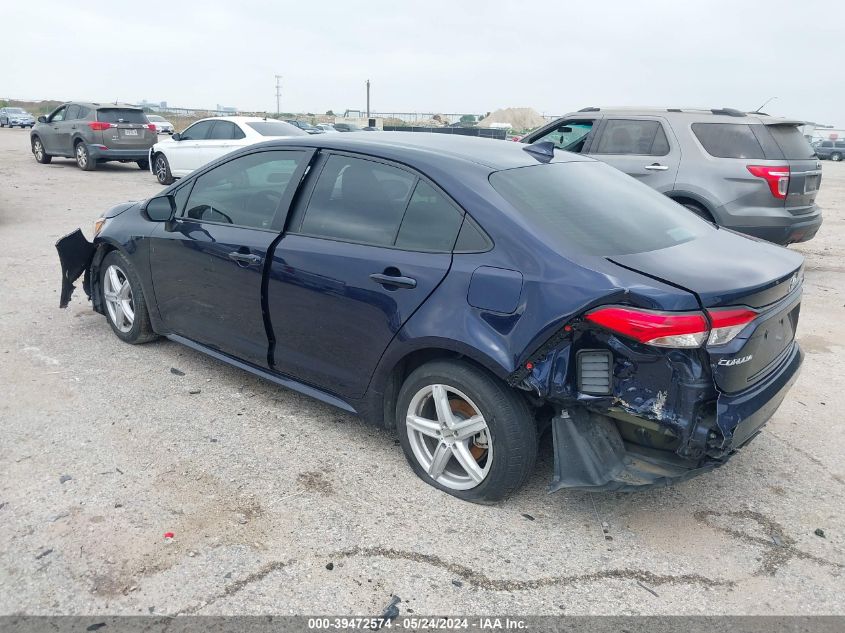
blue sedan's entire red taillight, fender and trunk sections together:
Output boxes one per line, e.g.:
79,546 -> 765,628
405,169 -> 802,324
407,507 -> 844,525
585,306 -> 757,348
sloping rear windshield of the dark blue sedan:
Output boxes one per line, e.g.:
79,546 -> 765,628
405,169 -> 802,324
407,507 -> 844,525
490,161 -> 713,256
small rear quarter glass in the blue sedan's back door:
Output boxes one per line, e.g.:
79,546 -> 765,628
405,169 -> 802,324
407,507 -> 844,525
395,180 -> 462,253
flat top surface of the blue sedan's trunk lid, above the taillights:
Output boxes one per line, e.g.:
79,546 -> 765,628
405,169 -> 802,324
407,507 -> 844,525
607,229 -> 804,307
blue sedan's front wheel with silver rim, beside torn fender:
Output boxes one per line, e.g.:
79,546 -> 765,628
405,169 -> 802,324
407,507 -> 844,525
100,251 -> 157,345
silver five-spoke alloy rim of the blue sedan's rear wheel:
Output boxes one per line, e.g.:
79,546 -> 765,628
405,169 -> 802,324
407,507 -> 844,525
405,384 -> 493,490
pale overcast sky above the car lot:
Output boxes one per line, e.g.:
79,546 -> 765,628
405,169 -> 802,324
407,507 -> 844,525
0,0 -> 845,126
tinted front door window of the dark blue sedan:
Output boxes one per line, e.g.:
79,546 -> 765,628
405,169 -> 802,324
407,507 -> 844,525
184,151 -> 305,229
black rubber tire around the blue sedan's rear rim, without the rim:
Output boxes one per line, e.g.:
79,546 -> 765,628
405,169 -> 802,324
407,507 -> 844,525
396,361 -> 537,503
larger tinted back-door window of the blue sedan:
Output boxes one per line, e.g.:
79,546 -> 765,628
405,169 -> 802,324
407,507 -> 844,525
301,155 -> 416,246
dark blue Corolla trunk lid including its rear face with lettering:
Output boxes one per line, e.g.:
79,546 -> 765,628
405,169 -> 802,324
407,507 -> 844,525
608,229 -> 803,393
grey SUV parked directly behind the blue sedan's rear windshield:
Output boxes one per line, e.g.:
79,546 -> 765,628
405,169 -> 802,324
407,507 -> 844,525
522,108 -> 822,244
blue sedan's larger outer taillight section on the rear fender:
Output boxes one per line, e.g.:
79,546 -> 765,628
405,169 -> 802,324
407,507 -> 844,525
585,307 -> 710,347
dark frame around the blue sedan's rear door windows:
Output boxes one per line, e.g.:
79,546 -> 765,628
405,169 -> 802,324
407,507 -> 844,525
284,149 -> 474,254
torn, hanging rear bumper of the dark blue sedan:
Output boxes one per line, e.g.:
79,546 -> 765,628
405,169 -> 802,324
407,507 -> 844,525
550,343 -> 804,492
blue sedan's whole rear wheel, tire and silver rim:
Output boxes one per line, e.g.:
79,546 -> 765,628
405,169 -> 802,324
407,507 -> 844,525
396,361 -> 537,503
